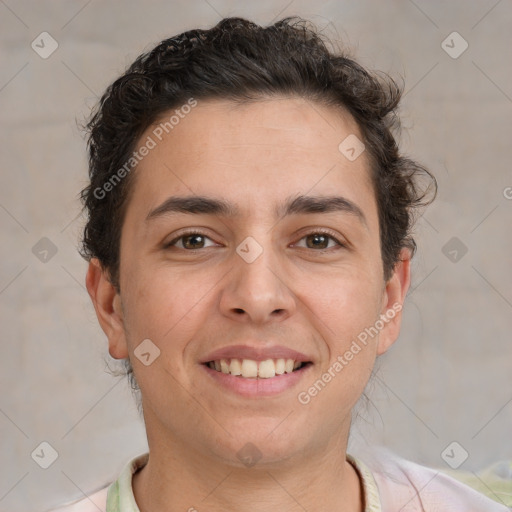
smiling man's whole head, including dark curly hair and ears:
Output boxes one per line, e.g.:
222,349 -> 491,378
82,18 -> 435,463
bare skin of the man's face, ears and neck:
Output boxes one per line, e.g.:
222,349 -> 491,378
86,97 -> 410,512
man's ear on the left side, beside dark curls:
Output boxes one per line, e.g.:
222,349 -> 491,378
85,258 -> 128,359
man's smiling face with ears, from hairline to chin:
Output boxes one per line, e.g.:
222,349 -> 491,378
87,98 -> 409,465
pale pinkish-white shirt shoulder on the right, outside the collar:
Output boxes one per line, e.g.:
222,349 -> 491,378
359,451 -> 509,512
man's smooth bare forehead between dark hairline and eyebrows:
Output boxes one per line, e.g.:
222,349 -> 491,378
124,98 -> 374,224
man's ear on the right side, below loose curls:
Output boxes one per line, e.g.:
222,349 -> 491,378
377,248 -> 411,356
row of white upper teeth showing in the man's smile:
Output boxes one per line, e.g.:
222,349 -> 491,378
208,359 -> 302,379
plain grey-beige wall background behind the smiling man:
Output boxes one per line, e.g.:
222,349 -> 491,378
0,0 -> 512,512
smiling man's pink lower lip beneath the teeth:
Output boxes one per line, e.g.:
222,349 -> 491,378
201,364 -> 312,398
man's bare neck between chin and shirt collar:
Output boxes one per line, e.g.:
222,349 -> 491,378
133,420 -> 363,512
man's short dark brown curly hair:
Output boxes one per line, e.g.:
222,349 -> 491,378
81,17 -> 437,291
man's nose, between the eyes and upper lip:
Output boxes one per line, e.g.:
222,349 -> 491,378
220,241 -> 296,324
